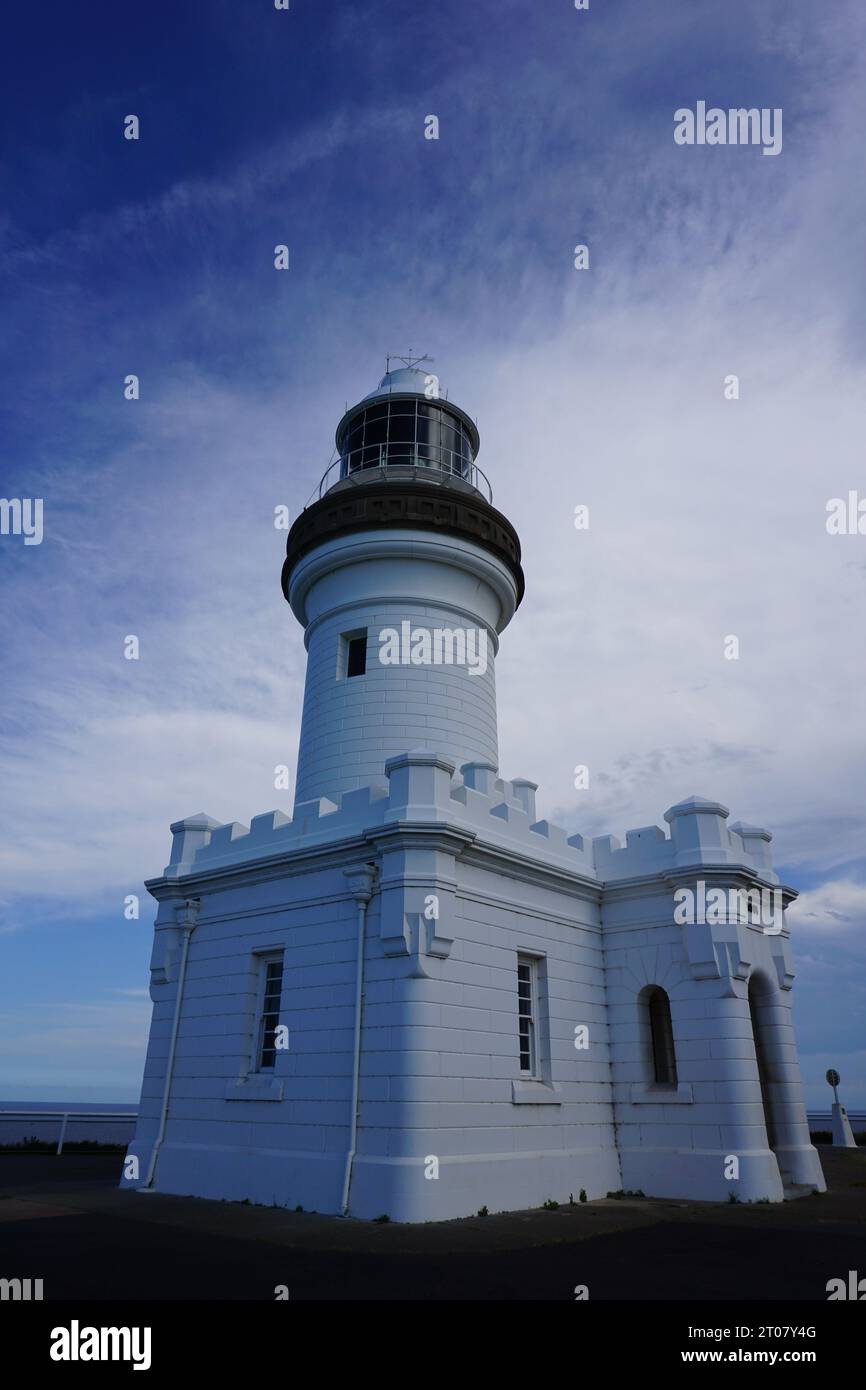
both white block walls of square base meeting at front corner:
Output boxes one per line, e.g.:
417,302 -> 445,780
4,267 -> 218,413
131,834 -> 620,1220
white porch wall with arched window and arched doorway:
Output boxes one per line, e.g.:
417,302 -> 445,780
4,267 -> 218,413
603,890 -> 824,1202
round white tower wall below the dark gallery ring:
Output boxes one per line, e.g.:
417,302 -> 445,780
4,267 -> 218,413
288,528 -> 517,805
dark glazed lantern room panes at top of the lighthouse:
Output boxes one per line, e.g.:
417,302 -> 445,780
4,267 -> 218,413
339,398 -> 473,478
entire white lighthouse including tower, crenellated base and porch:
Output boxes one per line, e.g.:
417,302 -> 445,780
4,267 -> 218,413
124,359 -> 824,1222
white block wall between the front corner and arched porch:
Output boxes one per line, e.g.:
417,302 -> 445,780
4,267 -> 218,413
352,870 -> 621,1220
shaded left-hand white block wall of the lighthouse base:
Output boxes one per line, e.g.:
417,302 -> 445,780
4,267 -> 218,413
131,867 -> 377,1211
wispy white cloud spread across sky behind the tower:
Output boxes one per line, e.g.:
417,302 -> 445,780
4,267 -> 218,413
0,0 -> 866,930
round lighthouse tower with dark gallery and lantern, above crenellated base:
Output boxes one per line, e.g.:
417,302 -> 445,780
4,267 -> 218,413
282,367 -> 524,803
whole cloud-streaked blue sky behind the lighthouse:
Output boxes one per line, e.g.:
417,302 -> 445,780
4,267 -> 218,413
0,0 -> 866,1106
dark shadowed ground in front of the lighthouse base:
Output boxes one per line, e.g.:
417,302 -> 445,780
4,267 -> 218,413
0,1148 -> 866,1302
